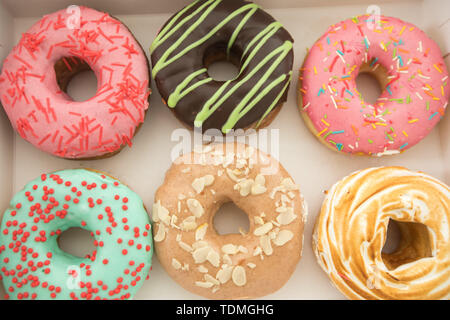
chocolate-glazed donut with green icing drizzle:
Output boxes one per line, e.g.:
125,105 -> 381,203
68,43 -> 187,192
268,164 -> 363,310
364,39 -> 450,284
150,0 -> 293,134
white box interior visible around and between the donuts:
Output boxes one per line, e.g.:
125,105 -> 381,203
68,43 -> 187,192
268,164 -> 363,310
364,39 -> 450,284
0,0 -> 450,299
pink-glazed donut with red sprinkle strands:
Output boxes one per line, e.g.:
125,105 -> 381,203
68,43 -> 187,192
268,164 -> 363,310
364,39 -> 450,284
0,6 -> 150,159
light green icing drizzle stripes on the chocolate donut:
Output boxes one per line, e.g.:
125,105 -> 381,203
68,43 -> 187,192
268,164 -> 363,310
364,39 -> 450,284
150,0 -> 293,133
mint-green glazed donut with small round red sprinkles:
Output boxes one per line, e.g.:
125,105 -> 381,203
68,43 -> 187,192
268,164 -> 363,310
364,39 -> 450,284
0,169 -> 153,300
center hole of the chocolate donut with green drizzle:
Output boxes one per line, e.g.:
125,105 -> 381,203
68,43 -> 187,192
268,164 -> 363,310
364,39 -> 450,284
203,43 -> 240,82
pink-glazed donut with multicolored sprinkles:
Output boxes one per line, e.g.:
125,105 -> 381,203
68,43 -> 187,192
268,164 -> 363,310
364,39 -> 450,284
298,15 -> 450,156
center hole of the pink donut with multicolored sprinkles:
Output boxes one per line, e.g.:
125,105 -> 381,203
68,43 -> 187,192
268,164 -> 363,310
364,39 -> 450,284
355,63 -> 388,105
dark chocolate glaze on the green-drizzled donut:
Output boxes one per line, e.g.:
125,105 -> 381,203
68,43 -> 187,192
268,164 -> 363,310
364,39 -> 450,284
151,0 -> 293,132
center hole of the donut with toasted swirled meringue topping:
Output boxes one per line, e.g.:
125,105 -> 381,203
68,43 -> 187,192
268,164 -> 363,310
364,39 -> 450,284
381,219 -> 433,270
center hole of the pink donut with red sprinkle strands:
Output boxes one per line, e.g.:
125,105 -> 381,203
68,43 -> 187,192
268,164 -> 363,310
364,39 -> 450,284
54,57 -> 97,102
